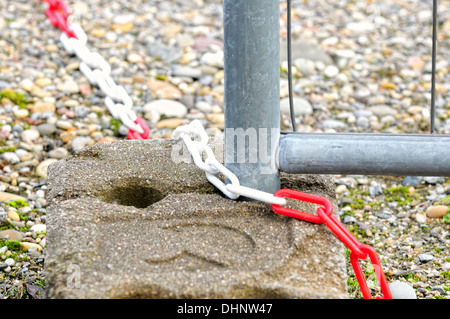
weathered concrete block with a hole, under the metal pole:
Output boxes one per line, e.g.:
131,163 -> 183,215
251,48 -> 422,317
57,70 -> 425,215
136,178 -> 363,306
45,139 -> 349,299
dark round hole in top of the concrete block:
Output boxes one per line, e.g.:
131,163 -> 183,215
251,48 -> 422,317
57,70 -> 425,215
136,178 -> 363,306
102,185 -> 165,208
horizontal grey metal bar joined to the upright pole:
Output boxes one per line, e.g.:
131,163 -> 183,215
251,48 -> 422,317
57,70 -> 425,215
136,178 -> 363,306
277,133 -> 450,176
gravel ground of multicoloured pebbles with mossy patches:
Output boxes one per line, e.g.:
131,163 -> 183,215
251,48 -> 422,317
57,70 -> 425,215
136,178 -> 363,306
0,0 -> 450,299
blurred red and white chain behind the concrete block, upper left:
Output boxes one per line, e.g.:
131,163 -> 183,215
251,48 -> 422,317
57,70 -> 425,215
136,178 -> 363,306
41,0 -> 150,139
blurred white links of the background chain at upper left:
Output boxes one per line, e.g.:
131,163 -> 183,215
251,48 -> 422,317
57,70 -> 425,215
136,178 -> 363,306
60,23 -> 144,134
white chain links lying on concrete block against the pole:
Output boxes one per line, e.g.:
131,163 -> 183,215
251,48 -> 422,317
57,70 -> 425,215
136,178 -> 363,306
172,120 -> 286,205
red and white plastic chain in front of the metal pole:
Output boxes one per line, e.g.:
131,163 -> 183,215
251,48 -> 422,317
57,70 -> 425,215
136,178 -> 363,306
172,120 -> 392,299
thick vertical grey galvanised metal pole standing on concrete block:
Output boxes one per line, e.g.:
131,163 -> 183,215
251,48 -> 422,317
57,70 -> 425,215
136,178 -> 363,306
223,0 -> 280,193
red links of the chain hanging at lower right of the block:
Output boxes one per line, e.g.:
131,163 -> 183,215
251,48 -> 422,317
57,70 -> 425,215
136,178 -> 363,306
271,188 -> 392,299
